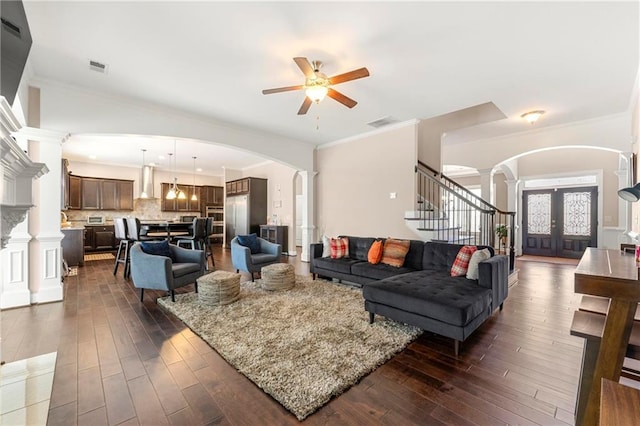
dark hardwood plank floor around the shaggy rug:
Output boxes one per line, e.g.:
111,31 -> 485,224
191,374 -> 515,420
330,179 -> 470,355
2,249 -> 582,426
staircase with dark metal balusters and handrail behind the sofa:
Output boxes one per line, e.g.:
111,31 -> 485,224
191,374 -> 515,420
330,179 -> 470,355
405,162 -> 515,270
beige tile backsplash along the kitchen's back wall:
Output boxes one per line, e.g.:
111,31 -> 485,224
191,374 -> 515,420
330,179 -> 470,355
65,198 -> 200,223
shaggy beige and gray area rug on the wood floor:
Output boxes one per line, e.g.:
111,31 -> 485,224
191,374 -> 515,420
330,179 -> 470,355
158,276 -> 421,420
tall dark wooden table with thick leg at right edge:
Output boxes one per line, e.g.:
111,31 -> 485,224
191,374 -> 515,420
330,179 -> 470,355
572,247 -> 640,426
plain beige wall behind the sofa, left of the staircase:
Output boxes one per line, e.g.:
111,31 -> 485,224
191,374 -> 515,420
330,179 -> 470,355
316,124 -> 418,238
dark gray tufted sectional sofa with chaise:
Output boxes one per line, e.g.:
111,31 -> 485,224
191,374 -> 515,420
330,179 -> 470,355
310,237 -> 509,356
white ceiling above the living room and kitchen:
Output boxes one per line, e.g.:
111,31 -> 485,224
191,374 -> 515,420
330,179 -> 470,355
20,0 -> 639,170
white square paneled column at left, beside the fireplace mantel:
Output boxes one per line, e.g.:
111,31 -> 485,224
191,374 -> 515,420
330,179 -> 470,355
14,127 -> 69,303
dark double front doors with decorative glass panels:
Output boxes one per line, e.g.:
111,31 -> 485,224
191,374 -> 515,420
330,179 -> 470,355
522,186 -> 598,259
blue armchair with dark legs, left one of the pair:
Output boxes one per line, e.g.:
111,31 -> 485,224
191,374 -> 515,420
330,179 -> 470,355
130,243 -> 205,302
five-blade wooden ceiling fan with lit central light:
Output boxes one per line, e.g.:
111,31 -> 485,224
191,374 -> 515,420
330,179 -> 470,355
262,57 -> 369,115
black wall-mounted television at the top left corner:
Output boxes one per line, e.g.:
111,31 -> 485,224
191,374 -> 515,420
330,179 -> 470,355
0,0 -> 31,105
